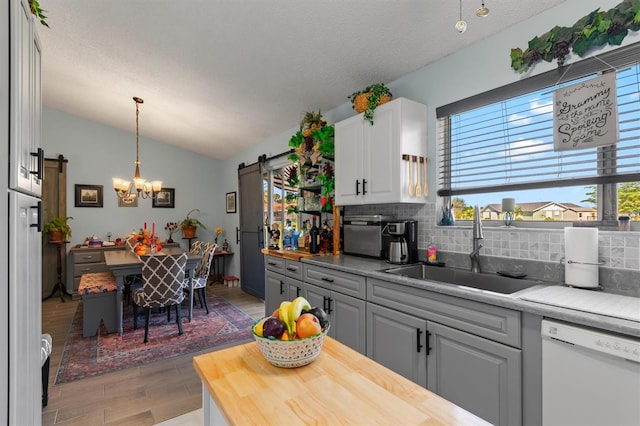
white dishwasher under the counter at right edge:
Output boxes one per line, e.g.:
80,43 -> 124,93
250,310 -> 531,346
542,319 -> 640,426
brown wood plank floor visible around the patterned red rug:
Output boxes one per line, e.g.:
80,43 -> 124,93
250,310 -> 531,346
42,284 -> 264,425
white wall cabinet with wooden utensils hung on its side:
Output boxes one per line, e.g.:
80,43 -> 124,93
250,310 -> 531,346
335,98 -> 427,206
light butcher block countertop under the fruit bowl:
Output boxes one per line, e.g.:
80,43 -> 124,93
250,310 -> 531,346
193,337 -> 488,425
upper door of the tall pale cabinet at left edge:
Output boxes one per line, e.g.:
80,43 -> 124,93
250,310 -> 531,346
9,0 -> 44,196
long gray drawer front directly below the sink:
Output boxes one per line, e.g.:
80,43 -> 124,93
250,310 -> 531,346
367,278 -> 522,348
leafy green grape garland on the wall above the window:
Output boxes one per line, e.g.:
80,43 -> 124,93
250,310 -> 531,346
511,0 -> 640,74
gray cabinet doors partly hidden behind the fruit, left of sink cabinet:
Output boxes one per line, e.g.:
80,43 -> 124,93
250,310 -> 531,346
302,283 -> 367,355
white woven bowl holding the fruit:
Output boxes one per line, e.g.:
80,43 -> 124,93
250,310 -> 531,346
251,318 -> 331,368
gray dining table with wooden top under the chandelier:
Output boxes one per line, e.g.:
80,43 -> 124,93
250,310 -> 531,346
104,247 -> 202,335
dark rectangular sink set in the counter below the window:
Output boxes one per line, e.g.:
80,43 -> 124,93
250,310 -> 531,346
384,264 -> 541,294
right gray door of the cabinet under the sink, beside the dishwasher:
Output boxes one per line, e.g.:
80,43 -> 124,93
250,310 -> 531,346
427,321 -> 522,425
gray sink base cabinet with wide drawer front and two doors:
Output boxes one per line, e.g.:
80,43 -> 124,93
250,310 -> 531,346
367,279 -> 523,425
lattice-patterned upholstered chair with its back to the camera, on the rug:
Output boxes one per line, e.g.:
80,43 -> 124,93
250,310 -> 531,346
131,253 -> 187,343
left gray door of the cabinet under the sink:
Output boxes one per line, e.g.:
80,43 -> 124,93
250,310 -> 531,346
367,303 -> 428,387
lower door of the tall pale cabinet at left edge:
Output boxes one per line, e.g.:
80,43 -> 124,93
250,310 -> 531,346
5,191 -> 42,425
